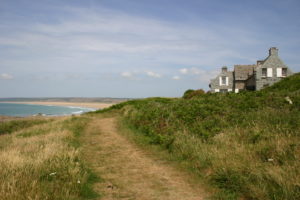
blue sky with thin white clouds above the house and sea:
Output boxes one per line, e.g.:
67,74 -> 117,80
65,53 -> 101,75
0,0 -> 300,98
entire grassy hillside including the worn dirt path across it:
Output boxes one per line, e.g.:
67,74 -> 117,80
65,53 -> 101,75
0,74 -> 300,200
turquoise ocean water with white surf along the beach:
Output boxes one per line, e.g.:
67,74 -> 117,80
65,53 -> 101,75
0,103 -> 94,117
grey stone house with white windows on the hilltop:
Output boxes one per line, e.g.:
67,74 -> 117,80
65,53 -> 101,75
209,47 -> 292,93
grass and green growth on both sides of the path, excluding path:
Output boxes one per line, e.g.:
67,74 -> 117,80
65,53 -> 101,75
0,74 -> 300,200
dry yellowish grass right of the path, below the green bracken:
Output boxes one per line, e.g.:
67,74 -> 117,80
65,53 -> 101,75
172,129 -> 300,200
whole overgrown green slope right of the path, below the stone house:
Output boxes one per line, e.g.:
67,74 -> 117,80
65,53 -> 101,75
100,73 -> 300,200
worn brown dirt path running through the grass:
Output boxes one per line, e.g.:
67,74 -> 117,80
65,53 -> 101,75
84,118 -> 204,200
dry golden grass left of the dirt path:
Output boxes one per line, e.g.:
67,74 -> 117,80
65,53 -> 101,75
0,117 -> 98,200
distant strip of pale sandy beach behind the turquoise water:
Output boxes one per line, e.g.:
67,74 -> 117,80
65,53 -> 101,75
3,101 -> 113,109
